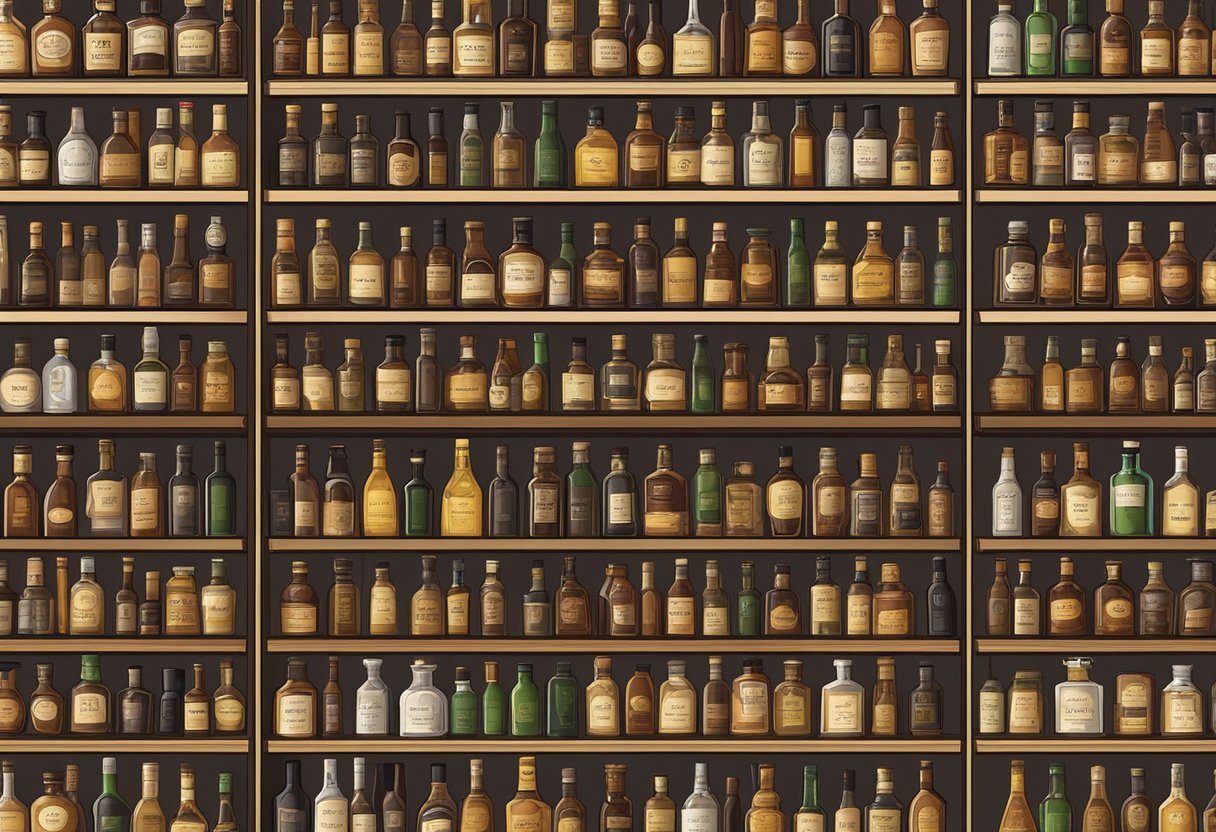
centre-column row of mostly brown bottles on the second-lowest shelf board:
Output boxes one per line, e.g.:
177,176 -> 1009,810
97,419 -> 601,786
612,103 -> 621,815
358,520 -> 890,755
278,555 -> 958,639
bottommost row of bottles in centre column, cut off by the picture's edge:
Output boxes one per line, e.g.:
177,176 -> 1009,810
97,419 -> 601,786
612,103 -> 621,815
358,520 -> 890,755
272,757 -> 946,832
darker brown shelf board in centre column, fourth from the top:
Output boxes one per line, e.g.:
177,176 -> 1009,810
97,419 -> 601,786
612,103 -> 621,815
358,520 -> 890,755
266,414 -> 958,434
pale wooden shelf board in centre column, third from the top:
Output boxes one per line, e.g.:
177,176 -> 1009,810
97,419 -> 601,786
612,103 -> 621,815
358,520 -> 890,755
266,307 -> 958,326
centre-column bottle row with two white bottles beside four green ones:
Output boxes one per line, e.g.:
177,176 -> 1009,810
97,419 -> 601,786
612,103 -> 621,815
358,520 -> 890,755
274,656 -> 942,738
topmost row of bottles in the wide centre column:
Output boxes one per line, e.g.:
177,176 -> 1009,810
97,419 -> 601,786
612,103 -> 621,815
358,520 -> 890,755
271,0 -> 950,78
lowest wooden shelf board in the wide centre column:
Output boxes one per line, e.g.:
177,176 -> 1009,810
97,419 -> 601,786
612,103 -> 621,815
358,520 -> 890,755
266,737 -> 958,754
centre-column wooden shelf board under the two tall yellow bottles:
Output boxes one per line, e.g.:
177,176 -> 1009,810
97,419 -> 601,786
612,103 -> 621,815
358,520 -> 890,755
266,538 -> 958,555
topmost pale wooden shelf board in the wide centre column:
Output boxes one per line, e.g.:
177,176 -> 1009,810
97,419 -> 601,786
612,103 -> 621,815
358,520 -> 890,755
265,78 -> 962,97
